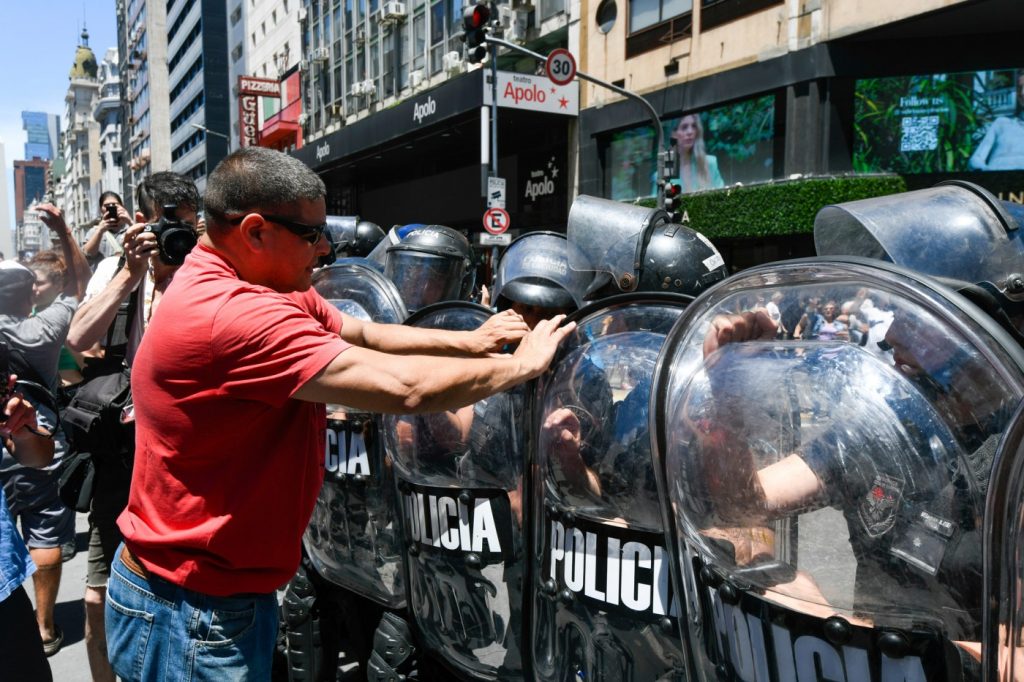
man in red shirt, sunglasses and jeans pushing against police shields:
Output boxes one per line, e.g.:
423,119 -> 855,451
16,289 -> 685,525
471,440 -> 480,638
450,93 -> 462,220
106,147 -> 572,680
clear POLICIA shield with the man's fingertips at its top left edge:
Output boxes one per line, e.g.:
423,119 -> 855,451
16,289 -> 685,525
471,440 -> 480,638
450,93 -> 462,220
529,294 -> 690,682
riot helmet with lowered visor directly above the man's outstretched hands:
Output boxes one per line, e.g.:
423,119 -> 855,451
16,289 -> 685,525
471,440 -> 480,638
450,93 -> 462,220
493,231 -> 592,311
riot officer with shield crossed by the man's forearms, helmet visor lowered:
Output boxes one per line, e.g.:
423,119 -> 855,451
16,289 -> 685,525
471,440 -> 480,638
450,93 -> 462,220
370,232 -> 590,680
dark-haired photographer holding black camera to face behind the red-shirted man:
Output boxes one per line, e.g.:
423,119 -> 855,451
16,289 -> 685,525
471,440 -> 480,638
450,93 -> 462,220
68,172 -> 200,682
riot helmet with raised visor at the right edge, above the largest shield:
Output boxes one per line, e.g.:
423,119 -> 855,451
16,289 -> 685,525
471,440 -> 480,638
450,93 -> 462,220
814,180 -> 1024,332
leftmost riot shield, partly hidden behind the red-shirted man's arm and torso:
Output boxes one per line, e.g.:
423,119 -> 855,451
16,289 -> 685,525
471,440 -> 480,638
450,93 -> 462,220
303,258 -> 407,608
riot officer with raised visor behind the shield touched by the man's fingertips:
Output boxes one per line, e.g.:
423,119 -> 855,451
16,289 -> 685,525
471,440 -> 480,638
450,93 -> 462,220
529,197 -> 727,680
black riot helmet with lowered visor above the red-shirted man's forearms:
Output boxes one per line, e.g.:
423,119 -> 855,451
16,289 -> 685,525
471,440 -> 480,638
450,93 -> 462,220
384,225 -> 474,312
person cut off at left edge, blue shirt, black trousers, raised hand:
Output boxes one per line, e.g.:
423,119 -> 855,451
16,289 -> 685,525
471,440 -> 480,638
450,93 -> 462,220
0,385 -> 53,682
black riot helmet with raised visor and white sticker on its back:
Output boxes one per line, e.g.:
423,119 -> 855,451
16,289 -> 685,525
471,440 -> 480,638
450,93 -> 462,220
567,191 -> 729,300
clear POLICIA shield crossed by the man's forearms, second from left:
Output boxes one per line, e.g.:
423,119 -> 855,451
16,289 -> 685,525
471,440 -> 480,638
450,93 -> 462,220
386,301 -> 525,680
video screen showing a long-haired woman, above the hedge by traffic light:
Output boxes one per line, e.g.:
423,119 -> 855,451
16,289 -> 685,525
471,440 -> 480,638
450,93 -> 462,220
605,95 -> 775,201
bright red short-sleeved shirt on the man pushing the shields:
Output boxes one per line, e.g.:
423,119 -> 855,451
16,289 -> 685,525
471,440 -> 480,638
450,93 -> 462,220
118,246 -> 349,596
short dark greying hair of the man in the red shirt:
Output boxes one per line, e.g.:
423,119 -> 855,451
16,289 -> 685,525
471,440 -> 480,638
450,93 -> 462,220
205,146 -> 327,231
